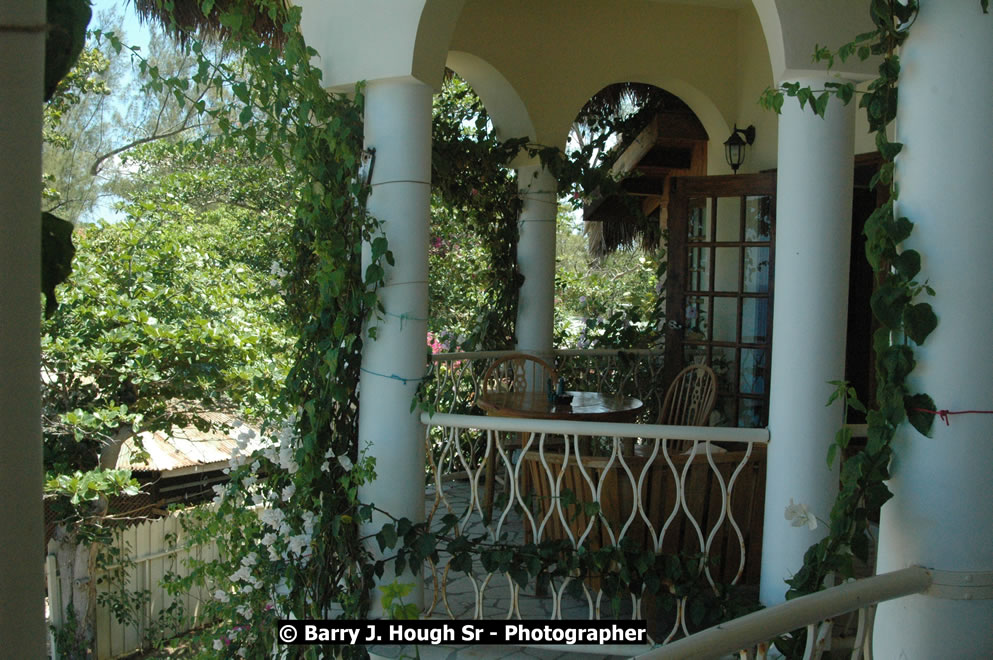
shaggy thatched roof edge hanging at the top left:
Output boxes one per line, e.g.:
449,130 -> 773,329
131,0 -> 289,47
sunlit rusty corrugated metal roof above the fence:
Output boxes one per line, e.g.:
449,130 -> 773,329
117,413 -> 261,472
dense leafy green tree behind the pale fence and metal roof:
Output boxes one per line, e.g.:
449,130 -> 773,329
42,135 -> 291,646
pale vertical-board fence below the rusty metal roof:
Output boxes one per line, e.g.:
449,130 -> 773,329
46,513 -> 217,660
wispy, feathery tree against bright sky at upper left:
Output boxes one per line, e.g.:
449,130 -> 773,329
43,13 -> 229,224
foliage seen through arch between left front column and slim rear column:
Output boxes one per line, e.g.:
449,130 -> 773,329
428,75 -> 525,351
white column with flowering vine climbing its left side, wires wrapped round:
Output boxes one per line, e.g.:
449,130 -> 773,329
359,79 -> 432,604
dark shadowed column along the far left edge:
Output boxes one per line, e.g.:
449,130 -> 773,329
0,0 -> 45,658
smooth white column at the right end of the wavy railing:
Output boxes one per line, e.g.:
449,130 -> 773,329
760,77 -> 855,605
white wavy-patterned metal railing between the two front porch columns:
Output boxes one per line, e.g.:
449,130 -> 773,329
421,413 -> 769,641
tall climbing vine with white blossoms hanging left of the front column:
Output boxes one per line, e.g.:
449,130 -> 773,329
89,0 -> 393,658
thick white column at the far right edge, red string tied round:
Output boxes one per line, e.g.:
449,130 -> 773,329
875,0 -> 993,659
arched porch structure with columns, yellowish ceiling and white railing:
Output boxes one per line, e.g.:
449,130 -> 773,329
0,0 -> 993,658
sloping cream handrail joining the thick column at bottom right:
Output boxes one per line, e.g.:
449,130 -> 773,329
637,566 -> 932,660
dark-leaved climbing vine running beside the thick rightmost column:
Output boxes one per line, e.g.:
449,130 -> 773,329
761,0 -> 989,651
